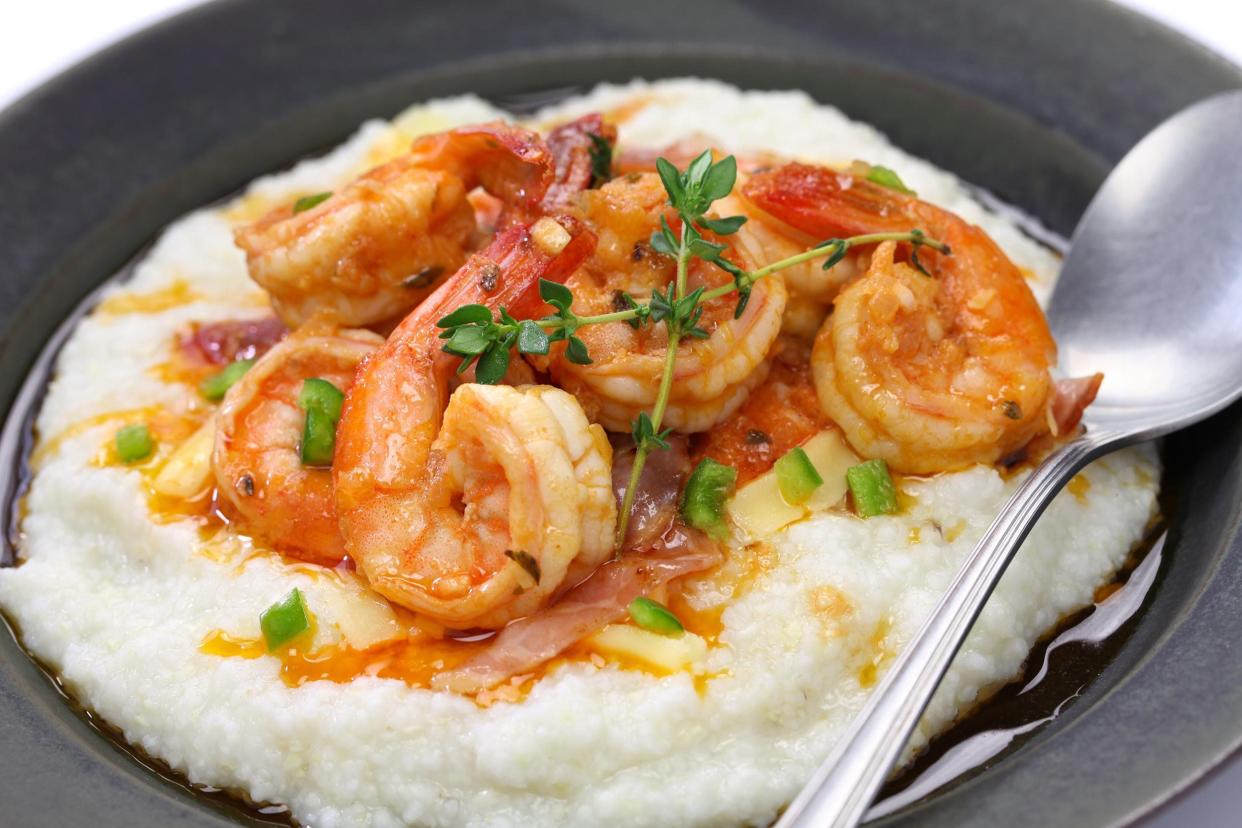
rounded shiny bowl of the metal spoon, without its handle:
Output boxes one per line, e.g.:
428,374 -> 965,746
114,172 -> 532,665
1048,92 -> 1242,438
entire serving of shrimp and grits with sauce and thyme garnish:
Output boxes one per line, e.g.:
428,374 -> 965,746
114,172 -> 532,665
0,79 -> 1160,828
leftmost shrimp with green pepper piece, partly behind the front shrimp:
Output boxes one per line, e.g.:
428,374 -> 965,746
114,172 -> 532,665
211,318 -> 384,566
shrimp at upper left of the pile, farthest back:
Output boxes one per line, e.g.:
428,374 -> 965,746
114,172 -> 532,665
233,122 -> 553,326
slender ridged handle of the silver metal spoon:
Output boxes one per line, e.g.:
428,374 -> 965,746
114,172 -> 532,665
776,433 -> 1120,828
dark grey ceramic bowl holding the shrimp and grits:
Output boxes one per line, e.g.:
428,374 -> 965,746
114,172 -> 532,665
0,0 -> 1242,828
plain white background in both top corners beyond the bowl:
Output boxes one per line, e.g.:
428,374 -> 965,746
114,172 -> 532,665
0,0 -> 1242,108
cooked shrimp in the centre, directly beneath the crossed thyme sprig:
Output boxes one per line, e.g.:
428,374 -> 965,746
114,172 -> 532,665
550,173 -> 785,432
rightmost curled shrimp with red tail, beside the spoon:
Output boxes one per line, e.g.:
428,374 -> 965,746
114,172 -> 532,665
748,164 -> 1057,474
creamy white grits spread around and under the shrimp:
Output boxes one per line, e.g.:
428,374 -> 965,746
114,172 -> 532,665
0,79 -> 1160,828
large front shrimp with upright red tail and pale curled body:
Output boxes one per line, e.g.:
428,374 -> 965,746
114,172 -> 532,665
333,217 -> 616,628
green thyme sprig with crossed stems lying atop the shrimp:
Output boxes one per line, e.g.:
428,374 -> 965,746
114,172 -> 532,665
436,150 -> 951,550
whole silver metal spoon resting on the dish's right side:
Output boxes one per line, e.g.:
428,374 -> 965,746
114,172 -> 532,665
776,91 -> 1242,828
